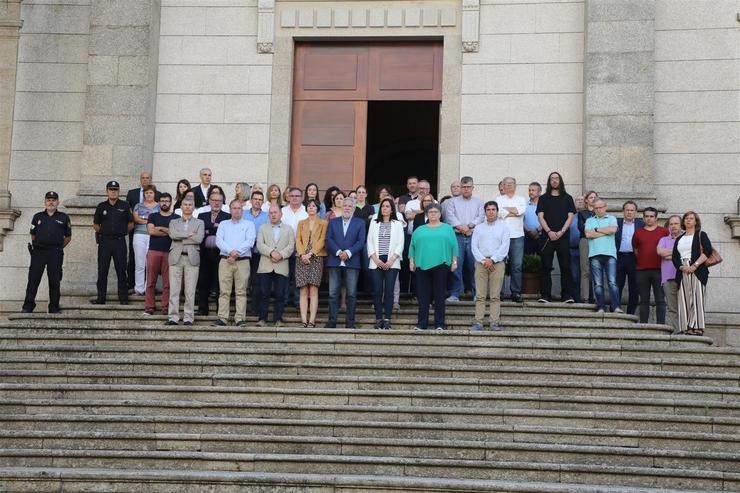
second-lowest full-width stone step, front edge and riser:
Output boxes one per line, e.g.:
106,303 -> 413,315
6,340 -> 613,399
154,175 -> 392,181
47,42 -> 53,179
0,449 -> 740,490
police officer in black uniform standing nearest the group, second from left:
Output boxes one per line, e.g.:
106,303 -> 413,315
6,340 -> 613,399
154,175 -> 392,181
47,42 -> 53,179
93,181 -> 134,305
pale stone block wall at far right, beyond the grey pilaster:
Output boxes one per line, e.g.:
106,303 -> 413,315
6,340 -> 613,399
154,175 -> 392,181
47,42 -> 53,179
655,0 -> 740,318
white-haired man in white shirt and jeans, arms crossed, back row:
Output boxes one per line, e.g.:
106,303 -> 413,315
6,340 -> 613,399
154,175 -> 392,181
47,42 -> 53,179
496,176 -> 527,303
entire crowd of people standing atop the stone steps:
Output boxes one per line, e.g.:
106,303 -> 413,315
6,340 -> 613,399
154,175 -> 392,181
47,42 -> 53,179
23,168 -> 713,335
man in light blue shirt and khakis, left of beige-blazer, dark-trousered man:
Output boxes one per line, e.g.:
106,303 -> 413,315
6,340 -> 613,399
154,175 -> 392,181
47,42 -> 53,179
213,199 -> 257,327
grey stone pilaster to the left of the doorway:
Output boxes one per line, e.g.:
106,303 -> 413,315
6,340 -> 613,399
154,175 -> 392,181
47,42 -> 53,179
73,0 -> 160,197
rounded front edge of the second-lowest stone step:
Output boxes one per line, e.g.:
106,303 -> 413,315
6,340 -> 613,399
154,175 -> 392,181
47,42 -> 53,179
0,448 -> 740,481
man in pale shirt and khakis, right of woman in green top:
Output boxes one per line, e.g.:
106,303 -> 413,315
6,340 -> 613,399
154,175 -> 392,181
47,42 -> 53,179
470,200 -> 511,330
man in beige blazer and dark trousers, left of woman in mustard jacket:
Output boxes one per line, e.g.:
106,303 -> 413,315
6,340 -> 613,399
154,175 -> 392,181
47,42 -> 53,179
256,204 -> 295,327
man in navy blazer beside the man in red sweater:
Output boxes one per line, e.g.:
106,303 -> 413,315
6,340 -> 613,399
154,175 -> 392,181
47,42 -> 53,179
614,200 -> 645,315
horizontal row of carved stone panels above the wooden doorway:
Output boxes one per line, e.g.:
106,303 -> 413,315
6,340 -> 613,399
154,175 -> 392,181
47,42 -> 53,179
280,6 -> 454,29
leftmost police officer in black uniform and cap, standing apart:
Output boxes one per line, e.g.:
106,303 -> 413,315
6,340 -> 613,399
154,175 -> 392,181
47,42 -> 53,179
23,192 -> 72,313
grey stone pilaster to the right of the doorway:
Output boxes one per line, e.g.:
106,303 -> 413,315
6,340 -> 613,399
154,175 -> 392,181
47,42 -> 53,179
583,0 -> 655,208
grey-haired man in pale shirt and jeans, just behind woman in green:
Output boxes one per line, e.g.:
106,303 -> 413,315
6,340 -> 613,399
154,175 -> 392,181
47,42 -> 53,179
445,176 -> 485,303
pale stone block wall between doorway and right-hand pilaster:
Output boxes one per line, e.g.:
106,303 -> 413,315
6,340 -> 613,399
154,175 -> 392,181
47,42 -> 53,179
460,0 -> 584,198
